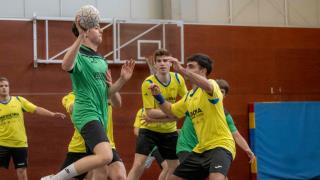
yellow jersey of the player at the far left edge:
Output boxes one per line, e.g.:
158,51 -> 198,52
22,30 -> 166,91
0,96 -> 37,147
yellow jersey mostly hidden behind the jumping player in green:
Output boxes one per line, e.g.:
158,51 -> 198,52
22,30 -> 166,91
62,92 -> 116,153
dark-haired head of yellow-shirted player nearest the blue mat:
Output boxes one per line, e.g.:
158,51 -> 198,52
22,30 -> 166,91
187,54 -> 213,76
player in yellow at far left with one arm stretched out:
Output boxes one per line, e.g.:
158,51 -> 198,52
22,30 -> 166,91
0,77 -> 65,180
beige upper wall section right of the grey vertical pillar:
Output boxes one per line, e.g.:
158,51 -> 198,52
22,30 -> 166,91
178,0 -> 320,27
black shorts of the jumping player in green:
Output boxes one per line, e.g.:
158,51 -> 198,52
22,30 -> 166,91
80,120 -> 109,153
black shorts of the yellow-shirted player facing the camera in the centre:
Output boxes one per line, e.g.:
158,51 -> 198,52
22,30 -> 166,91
136,129 -> 178,160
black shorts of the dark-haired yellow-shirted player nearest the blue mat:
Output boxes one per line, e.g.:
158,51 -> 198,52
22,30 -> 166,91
173,147 -> 232,180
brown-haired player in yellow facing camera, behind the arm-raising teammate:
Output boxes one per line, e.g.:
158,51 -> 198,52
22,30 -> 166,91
128,49 -> 187,180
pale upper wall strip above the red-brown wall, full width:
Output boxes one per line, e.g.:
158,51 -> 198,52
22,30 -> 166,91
0,0 -> 320,27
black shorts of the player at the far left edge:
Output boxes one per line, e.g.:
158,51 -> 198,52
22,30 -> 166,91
0,146 -> 28,169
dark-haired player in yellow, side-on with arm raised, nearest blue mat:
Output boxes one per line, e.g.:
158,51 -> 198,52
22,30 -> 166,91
149,54 -> 235,180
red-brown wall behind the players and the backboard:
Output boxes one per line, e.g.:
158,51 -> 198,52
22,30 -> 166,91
0,21 -> 320,180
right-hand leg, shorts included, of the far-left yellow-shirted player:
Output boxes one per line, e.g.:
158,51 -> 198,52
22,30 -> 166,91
11,147 -> 28,180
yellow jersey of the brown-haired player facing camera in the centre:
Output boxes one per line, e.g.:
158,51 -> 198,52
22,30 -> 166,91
140,72 -> 187,133
